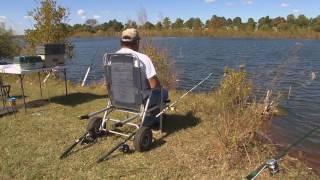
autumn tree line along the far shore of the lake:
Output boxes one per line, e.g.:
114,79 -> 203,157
64,14 -> 320,33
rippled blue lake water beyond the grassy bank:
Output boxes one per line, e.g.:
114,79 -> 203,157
68,37 -> 320,172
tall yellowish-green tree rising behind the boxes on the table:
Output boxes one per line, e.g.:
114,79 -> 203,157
25,0 -> 69,47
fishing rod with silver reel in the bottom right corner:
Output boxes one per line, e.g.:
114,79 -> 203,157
245,127 -> 320,180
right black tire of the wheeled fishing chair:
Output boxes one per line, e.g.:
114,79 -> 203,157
133,126 -> 152,152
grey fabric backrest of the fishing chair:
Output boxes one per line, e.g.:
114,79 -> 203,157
104,53 -> 143,112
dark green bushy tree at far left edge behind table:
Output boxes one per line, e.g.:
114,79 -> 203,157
0,23 -> 20,58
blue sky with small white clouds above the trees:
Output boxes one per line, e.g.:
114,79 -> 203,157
0,0 -> 320,34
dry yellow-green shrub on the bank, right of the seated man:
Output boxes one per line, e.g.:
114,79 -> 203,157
213,68 -> 266,161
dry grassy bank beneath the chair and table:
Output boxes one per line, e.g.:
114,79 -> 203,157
0,74 -> 319,179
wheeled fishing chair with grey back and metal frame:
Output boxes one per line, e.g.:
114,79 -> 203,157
82,53 -> 167,152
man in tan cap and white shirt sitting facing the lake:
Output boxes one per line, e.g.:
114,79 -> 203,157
116,28 -> 168,126
